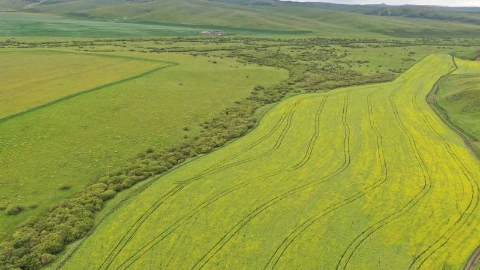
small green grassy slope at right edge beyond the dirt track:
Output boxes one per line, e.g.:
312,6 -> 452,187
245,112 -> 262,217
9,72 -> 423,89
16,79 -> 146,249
438,59 -> 480,150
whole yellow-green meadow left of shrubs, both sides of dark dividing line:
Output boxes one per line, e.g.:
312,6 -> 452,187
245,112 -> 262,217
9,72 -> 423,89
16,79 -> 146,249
0,50 -> 288,238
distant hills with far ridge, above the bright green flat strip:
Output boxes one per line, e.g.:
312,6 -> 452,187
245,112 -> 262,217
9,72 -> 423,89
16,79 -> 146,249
0,0 -> 480,37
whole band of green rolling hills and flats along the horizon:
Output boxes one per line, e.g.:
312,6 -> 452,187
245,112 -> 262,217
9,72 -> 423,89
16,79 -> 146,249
0,0 -> 480,38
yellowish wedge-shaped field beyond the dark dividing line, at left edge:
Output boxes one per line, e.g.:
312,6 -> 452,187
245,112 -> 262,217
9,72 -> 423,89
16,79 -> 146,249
0,50 -> 167,120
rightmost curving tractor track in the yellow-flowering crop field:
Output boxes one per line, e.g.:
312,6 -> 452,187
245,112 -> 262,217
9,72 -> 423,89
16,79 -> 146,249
409,73 -> 480,269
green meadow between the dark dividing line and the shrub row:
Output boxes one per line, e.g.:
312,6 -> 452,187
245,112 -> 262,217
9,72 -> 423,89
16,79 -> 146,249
0,48 -> 287,238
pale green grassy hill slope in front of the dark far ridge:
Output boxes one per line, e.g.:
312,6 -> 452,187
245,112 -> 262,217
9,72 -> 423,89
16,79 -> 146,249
8,0 -> 480,37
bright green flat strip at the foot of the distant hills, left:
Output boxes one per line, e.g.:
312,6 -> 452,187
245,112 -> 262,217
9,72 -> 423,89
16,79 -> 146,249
0,12 -> 310,39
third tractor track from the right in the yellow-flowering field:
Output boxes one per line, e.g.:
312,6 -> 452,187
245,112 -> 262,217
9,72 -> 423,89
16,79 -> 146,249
264,91 -> 388,269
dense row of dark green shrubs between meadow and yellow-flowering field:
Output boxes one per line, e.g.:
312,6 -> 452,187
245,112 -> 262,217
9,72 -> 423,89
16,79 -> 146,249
0,65 -> 291,269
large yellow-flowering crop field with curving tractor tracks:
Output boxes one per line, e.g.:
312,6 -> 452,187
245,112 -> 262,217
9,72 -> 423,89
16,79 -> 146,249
54,55 -> 480,269
